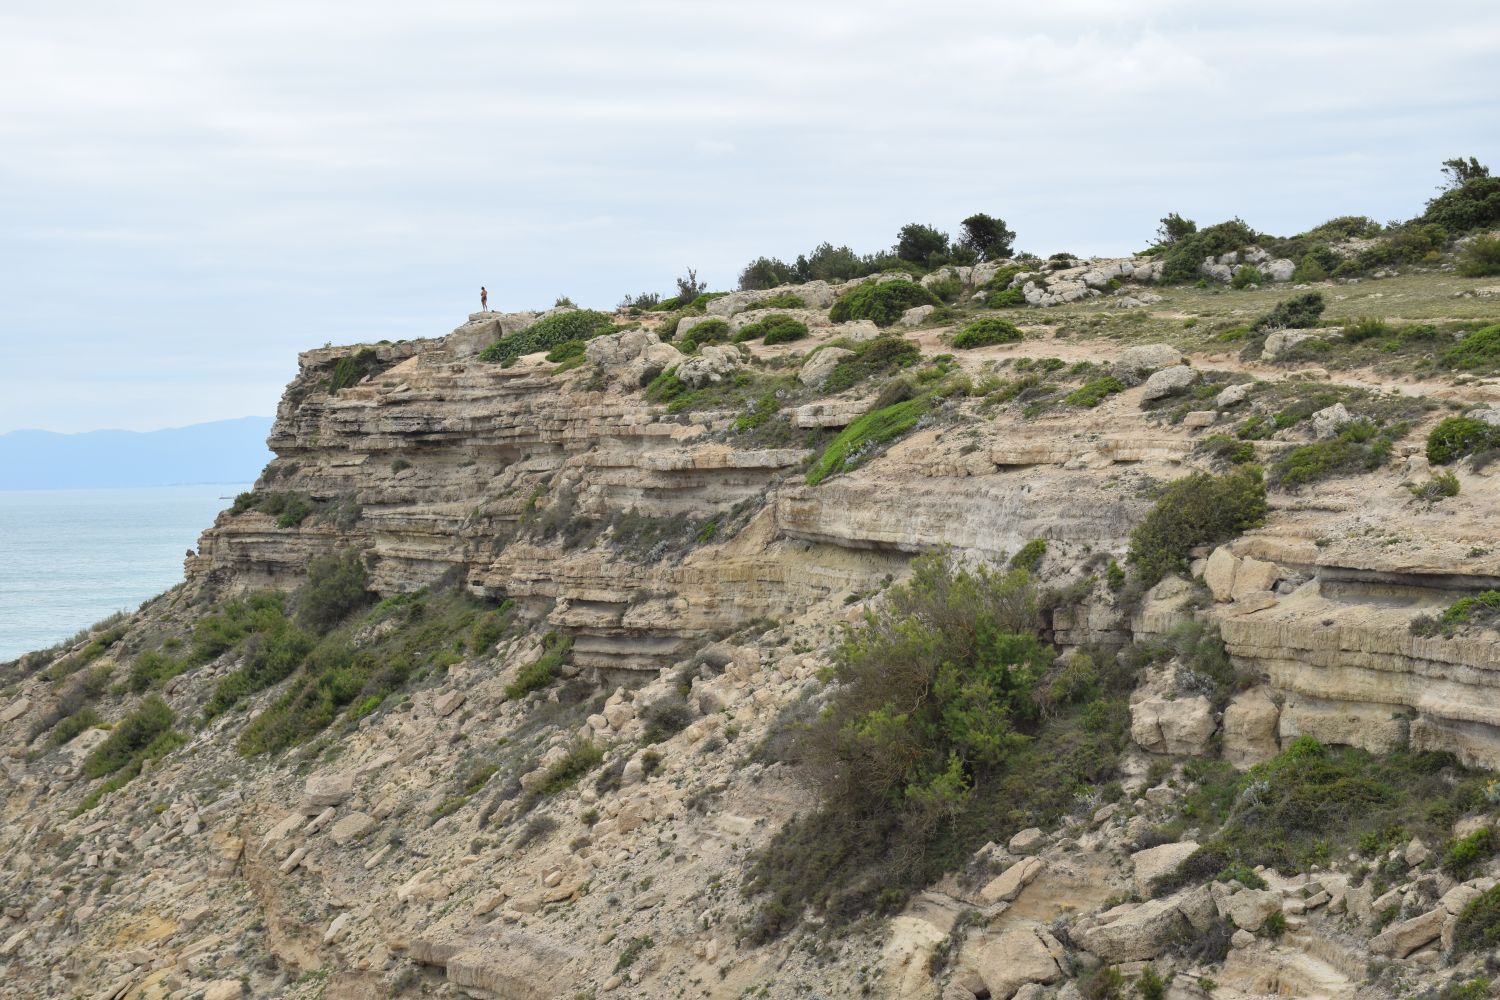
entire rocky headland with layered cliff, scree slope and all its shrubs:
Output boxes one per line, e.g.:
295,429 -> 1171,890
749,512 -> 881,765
0,159 -> 1500,1000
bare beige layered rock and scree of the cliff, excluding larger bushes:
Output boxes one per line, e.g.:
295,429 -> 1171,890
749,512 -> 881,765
0,248 -> 1500,1000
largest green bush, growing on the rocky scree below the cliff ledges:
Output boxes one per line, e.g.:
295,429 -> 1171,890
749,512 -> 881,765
747,553 -> 1128,940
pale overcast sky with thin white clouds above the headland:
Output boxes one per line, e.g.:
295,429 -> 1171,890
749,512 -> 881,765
0,0 -> 1500,433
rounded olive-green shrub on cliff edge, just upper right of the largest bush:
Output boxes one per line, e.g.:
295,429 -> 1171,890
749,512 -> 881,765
1128,466 -> 1266,586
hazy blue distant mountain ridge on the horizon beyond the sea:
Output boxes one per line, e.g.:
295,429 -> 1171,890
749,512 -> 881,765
0,417 -> 272,490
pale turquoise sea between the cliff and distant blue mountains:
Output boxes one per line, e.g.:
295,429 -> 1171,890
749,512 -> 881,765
0,484 -> 249,663
